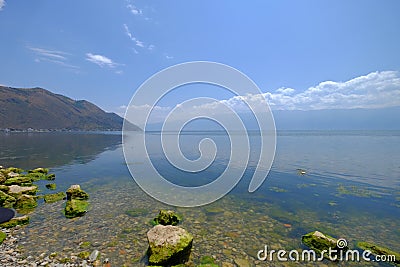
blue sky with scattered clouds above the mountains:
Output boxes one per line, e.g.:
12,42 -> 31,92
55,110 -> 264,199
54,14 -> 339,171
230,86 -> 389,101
0,0 -> 400,117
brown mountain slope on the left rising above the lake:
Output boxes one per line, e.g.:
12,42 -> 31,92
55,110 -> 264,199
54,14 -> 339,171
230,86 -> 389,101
0,86 -> 141,131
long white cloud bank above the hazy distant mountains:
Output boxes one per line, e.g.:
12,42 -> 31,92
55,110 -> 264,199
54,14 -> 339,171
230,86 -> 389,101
124,71 -> 400,126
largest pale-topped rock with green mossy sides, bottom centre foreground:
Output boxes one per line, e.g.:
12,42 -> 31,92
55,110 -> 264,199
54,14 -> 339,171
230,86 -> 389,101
147,225 -> 193,265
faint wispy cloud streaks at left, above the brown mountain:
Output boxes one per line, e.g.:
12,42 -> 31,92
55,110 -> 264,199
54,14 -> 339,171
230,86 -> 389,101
28,46 -> 79,69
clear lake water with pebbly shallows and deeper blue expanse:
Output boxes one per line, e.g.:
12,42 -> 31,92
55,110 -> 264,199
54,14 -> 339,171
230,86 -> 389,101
0,131 -> 400,266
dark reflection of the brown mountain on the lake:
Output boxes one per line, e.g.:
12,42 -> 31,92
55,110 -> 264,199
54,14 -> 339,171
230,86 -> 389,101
0,132 -> 121,169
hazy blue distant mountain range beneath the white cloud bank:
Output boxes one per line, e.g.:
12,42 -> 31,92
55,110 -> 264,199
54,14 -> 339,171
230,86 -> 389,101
146,107 -> 400,131
